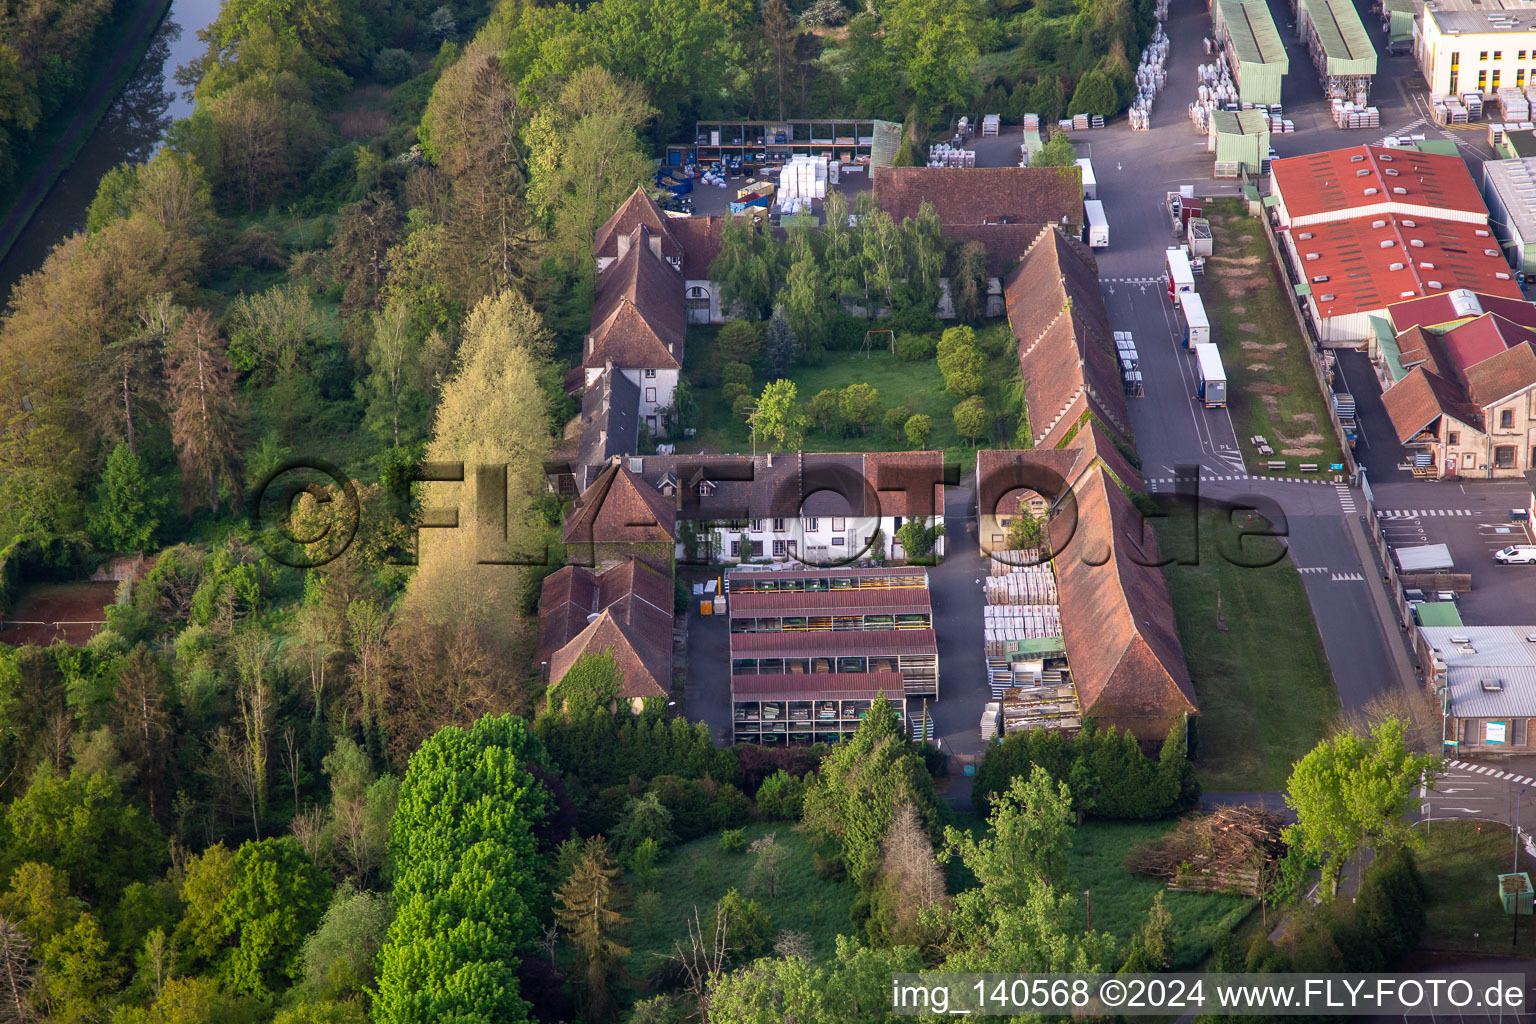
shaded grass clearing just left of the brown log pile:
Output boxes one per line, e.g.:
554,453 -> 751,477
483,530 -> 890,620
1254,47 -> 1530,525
949,815 -> 1258,970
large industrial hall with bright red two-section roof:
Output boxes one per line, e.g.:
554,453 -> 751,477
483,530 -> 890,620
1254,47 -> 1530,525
1269,146 -> 1521,345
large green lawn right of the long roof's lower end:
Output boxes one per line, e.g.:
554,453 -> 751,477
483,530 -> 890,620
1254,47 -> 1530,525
1154,507 -> 1339,791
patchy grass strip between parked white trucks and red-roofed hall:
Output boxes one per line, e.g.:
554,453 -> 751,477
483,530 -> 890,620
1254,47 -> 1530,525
1200,200 -> 1344,476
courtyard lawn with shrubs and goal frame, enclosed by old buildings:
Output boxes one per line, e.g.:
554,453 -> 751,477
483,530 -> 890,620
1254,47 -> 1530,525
684,319 -> 1018,462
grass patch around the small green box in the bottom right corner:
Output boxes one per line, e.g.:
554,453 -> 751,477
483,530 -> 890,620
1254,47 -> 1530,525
1415,821 -> 1536,956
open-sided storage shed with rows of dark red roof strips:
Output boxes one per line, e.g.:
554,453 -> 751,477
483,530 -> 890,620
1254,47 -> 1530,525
725,567 -> 938,745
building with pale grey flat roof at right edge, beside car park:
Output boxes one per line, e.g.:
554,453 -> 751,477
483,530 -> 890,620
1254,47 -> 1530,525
1418,625 -> 1536,754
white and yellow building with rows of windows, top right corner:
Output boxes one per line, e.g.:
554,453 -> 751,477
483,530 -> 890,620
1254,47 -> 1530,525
1413,0 -> 1536,97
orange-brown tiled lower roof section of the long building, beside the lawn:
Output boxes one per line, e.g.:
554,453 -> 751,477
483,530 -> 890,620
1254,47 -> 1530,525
1052,467 -> 1200,743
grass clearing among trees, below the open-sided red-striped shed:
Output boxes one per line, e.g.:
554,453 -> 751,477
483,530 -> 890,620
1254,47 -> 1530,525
624,821 -> 854,978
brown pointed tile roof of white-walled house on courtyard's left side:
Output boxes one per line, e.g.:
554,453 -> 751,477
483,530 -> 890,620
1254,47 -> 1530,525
582,226 -> 687,370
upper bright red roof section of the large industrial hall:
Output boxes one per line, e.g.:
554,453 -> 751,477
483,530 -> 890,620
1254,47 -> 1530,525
1270,146 -> 1488,227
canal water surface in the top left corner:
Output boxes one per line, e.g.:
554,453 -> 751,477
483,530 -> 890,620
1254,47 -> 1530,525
0,0 -> 220,306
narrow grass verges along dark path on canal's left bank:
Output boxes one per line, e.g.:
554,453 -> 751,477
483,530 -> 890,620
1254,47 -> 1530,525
0,0 -> 170,268
